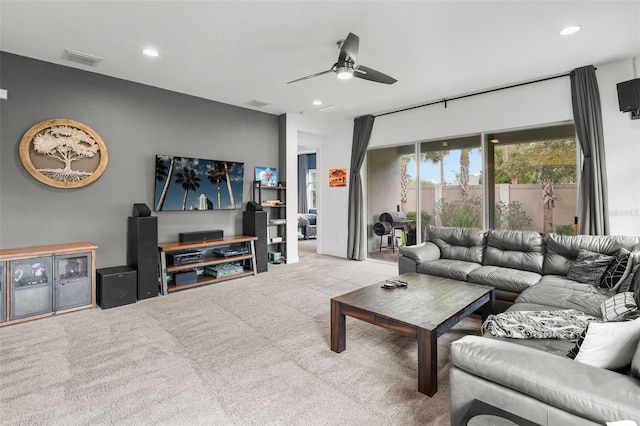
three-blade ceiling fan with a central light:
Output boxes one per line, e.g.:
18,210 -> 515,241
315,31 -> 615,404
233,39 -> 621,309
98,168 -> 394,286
287,33 -> 398,84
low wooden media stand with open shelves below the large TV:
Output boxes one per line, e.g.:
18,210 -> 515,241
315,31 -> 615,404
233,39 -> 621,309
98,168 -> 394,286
158,235 -> 257,295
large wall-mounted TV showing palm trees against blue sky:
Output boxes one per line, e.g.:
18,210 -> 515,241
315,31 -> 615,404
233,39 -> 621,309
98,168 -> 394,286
153,155 -> 244,211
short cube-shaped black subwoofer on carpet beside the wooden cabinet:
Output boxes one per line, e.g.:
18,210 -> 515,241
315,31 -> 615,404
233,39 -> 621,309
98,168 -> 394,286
96,266 -> 137,309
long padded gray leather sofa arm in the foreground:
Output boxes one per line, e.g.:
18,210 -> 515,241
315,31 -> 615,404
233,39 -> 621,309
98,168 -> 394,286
450,336 -> 640,425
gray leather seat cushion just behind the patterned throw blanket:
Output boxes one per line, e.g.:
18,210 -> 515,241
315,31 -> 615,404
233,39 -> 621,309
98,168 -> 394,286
516,275 -> 609,318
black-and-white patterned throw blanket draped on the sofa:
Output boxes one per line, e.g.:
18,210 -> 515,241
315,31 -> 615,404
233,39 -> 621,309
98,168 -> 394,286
482,309 -> 597,340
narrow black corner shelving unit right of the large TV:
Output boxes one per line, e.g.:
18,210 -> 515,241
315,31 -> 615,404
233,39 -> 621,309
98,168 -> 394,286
253,181 -> 287,263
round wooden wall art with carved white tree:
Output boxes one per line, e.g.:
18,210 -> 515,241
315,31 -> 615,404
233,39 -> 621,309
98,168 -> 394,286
20,118 -> 109,188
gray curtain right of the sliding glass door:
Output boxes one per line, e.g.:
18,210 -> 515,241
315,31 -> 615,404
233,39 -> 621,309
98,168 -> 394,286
571,65 -> 609,235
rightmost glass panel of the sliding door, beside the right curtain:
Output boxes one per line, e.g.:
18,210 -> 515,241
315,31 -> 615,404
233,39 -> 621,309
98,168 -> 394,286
488,124 -> 577,234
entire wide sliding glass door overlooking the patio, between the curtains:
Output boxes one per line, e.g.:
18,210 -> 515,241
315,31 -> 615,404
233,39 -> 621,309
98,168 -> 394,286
367,124 -> 577,261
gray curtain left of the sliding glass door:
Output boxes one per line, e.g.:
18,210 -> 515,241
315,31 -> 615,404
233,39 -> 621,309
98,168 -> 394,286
347,115 -> 375,260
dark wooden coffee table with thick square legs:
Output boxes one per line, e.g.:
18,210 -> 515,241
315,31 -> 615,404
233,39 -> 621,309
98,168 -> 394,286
331,273 -> 495,396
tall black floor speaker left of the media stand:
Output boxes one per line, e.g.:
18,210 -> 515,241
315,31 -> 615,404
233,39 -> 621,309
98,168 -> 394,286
127,216 -> 158,300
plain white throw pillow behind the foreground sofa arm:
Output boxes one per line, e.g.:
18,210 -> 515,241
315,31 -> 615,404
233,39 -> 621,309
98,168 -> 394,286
567,318 -> 640,370
